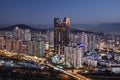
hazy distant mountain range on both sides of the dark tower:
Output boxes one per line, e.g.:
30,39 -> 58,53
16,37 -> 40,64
0,22 -> 120,34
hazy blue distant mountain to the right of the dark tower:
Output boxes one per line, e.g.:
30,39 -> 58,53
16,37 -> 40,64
71,22 -> 120,33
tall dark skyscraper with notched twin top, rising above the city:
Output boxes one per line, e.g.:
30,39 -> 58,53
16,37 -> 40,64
54,17 -> 70,54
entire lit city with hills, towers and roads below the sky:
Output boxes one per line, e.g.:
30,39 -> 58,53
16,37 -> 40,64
0,17 -> 120,80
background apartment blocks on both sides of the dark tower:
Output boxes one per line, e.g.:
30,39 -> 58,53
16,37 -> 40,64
0,26 -> 120,56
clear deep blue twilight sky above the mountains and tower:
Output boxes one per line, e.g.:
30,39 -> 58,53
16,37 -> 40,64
0,0 -> 120,24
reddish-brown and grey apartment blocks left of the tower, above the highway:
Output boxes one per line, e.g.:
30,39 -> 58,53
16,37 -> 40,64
0,26 -> 45,57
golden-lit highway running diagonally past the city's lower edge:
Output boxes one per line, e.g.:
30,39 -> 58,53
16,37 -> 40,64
0,50 -> 90,80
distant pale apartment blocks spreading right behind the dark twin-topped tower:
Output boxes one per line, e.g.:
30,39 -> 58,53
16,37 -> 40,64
70,32 -> 120,52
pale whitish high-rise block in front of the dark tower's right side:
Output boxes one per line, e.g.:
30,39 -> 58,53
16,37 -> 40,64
65,46 -> 83,68
